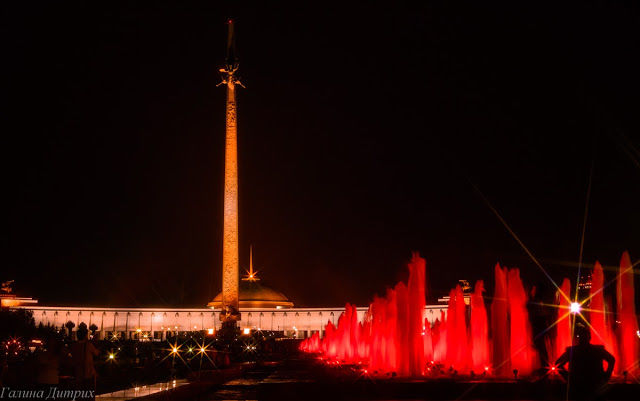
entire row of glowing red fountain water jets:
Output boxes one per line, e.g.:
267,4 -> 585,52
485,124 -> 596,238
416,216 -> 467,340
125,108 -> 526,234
300,252 -> 640,378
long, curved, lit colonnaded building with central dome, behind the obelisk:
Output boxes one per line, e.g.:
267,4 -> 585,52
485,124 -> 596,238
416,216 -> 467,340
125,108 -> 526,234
12,250 -> 448,341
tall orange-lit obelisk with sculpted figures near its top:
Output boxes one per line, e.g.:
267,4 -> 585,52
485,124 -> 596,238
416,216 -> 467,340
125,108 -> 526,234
220,20 -> 242,326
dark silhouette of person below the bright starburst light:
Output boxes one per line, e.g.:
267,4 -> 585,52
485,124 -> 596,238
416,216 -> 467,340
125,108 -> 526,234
556,326 -> 616,401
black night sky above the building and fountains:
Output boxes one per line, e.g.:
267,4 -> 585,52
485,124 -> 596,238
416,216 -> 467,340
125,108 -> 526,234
5,1 -> 640,307
